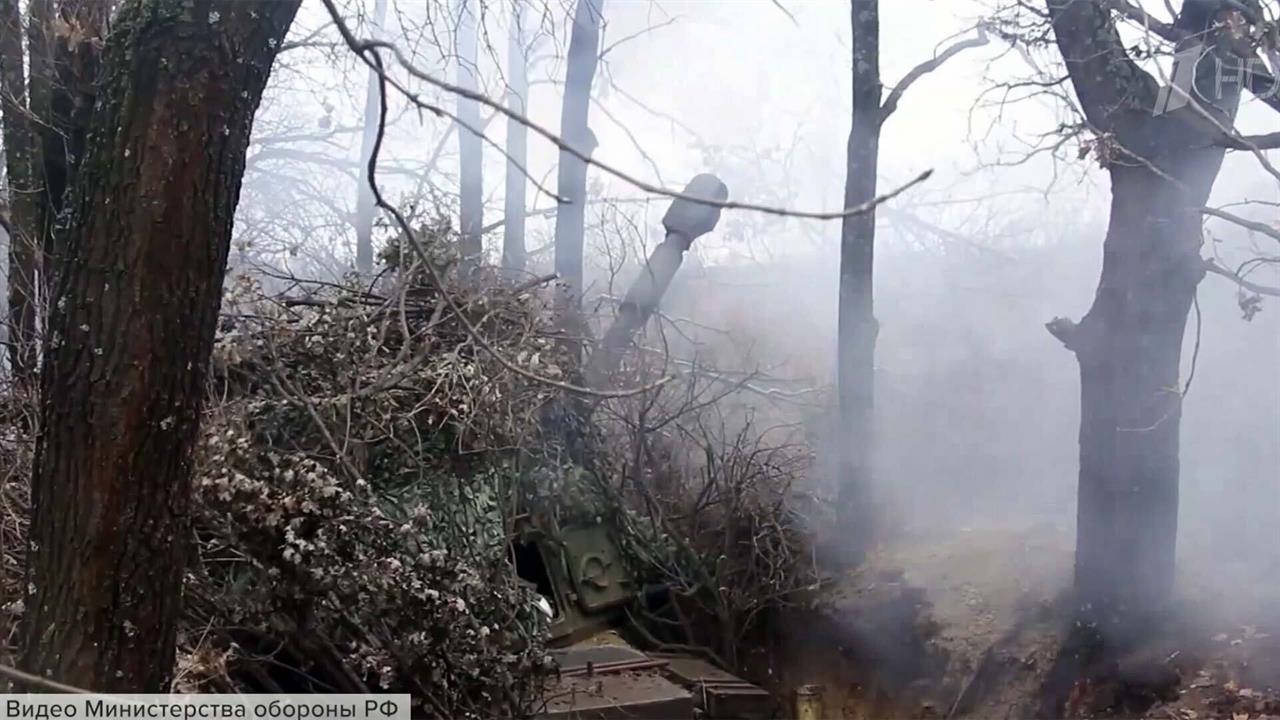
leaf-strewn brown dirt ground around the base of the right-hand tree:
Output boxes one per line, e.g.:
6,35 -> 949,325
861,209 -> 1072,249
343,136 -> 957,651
780,525 -> 1280,720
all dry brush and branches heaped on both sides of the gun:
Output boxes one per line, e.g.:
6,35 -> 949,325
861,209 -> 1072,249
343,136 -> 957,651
0,228 -> 813,717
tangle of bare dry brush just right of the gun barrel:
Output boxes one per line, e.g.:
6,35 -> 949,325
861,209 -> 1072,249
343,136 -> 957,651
585,343 -> 831,675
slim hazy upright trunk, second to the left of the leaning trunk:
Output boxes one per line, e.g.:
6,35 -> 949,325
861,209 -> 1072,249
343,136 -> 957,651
457,0 -> 484,274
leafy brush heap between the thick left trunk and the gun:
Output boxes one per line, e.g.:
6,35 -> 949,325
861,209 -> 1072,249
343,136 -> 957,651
0,233 -> 570,717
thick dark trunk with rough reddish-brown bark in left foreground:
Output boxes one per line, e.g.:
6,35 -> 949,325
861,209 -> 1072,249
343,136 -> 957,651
22,0 -> 298,692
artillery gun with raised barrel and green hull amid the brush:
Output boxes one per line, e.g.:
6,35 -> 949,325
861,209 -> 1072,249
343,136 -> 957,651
512,174 -> 778,720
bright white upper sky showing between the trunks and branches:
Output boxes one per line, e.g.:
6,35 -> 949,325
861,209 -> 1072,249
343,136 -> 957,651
291,0 -> 1275,257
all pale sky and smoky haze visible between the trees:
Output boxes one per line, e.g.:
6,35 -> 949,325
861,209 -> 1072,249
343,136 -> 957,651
242,0 -> 1280,702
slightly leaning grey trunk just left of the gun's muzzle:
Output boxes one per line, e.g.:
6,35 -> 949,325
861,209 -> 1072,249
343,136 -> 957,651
556,0 -> 604,308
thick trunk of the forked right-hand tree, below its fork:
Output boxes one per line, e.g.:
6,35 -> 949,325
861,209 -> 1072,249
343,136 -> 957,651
1064,134 -> 1222,638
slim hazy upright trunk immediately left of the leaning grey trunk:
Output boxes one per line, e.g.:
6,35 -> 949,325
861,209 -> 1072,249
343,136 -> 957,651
502,3 -> 529,275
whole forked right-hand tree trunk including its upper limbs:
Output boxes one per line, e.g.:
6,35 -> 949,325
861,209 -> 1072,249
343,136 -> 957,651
1048,0 -> 1239,638
